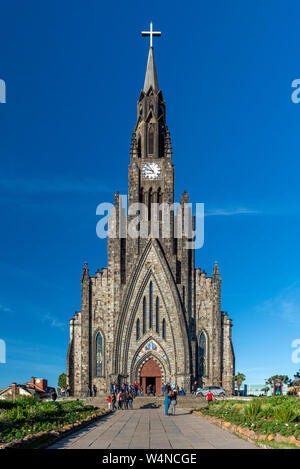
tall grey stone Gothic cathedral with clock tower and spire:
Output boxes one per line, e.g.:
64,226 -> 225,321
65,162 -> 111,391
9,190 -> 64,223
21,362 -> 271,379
67,37 -> 234,396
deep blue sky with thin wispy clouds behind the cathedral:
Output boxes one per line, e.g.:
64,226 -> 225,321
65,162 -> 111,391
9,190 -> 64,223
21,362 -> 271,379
0,0 -> 300,387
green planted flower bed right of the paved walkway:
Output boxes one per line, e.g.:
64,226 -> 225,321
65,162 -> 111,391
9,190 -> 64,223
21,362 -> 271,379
196,397 -> 300,447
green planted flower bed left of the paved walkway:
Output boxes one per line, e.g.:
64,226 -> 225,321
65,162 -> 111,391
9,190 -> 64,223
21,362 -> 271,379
0,398 -> 108,448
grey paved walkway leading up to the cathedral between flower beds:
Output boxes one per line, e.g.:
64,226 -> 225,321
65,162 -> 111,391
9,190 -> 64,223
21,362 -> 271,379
50,408 -> 256,449
